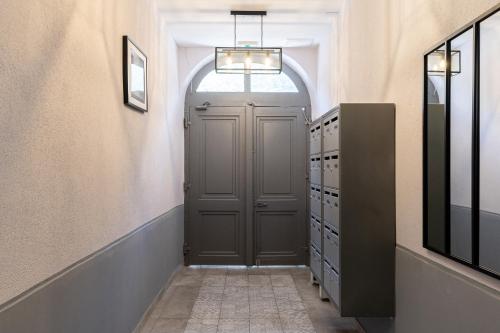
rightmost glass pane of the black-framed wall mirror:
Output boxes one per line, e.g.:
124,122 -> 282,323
479,12 -> 500,274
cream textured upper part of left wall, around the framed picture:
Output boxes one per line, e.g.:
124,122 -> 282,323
0,0 -> 183,304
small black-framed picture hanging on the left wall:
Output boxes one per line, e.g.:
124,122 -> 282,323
123,36 -> 148,112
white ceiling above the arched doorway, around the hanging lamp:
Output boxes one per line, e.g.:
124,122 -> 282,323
160,0 -> 343,47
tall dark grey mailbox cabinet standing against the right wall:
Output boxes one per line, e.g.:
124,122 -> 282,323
310,104 -> 395,317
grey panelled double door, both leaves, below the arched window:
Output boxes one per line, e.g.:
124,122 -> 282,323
186,104 -> 307,265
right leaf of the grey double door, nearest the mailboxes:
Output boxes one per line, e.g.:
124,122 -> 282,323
254,107 -> 307,264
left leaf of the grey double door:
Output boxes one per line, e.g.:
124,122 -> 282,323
188,107 -> 246,265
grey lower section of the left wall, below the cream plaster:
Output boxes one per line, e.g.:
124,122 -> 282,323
0,205 -> 184,333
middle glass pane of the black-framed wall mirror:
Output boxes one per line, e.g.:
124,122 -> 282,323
450,29 -> 474,262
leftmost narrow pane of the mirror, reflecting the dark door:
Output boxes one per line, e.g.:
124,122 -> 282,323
425,45 -> 446,252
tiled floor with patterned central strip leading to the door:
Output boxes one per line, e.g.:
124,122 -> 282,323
140,267 -> 358,333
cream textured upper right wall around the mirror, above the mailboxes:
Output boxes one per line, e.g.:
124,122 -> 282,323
339,0 -> 500,290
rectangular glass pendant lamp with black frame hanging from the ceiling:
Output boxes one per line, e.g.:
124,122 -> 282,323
215,11 -> 283,74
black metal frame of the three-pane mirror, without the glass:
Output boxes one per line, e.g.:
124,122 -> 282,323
422,5 -> 500,279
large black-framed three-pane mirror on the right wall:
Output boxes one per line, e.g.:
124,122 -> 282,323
423,6 -> 500,278
